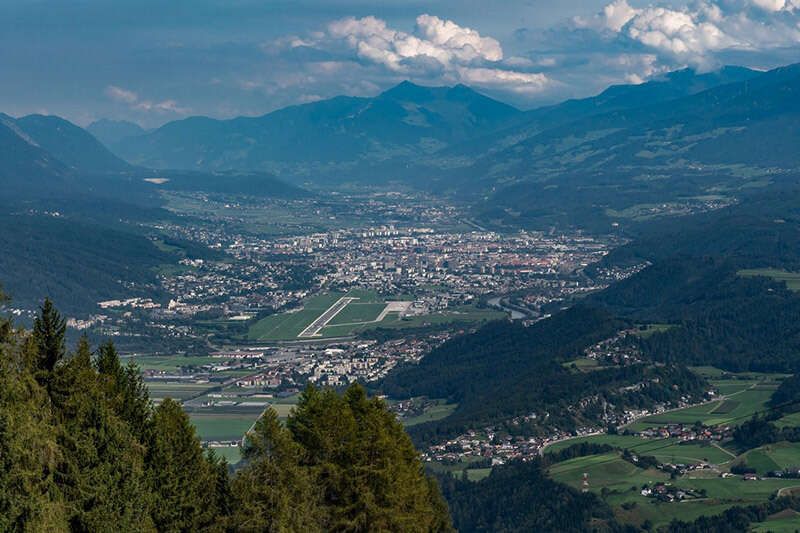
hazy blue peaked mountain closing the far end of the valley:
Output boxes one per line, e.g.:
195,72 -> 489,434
112,82 -> 521,170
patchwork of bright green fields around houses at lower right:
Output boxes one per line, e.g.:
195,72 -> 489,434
547,367 -> 800,531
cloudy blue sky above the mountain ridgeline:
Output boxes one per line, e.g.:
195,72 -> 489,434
0,0 -> 800,128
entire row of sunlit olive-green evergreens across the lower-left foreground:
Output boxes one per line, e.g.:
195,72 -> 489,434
0,301 -> 451,532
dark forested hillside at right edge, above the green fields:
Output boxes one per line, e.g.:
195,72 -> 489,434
588,189 -> 800,372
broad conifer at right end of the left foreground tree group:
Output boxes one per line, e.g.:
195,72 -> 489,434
147,398 -> 218,532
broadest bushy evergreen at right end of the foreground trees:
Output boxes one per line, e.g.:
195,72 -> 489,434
287,385 -> 450,532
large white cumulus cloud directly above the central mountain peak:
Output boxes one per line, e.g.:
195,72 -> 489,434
273,14 -> 552,94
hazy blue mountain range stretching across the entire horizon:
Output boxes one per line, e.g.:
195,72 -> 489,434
0,61 -> 800,232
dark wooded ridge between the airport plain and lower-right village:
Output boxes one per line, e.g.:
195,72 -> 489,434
381,306 -> 705,444
